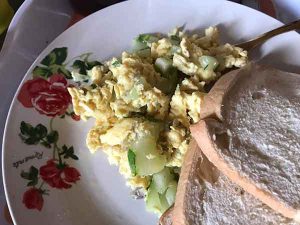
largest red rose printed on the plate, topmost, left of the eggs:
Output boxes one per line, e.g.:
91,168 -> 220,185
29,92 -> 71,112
18,74 -> 71,117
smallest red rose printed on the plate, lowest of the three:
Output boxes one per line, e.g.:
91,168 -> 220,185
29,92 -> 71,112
23,187 -> 44,211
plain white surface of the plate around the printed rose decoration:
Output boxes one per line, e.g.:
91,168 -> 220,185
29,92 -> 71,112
2,0 -> 300,225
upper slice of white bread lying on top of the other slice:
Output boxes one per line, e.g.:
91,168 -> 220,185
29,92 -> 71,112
191,64 -> 300,221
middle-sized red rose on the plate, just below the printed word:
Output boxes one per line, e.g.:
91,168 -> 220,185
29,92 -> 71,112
40,160 -> 81,189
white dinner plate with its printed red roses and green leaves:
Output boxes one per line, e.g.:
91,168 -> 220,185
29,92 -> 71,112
2,0 -> 300,225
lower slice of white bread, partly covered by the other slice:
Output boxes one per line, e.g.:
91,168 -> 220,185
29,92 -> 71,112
169,140 -> 295,225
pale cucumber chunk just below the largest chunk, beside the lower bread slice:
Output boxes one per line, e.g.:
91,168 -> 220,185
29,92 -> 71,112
152,167 -> 174,194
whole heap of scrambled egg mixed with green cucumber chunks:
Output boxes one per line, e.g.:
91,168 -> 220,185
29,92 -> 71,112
68,27 -> 247,214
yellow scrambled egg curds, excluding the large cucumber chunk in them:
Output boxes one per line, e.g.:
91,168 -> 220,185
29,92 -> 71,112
68,27 -> 247,189
